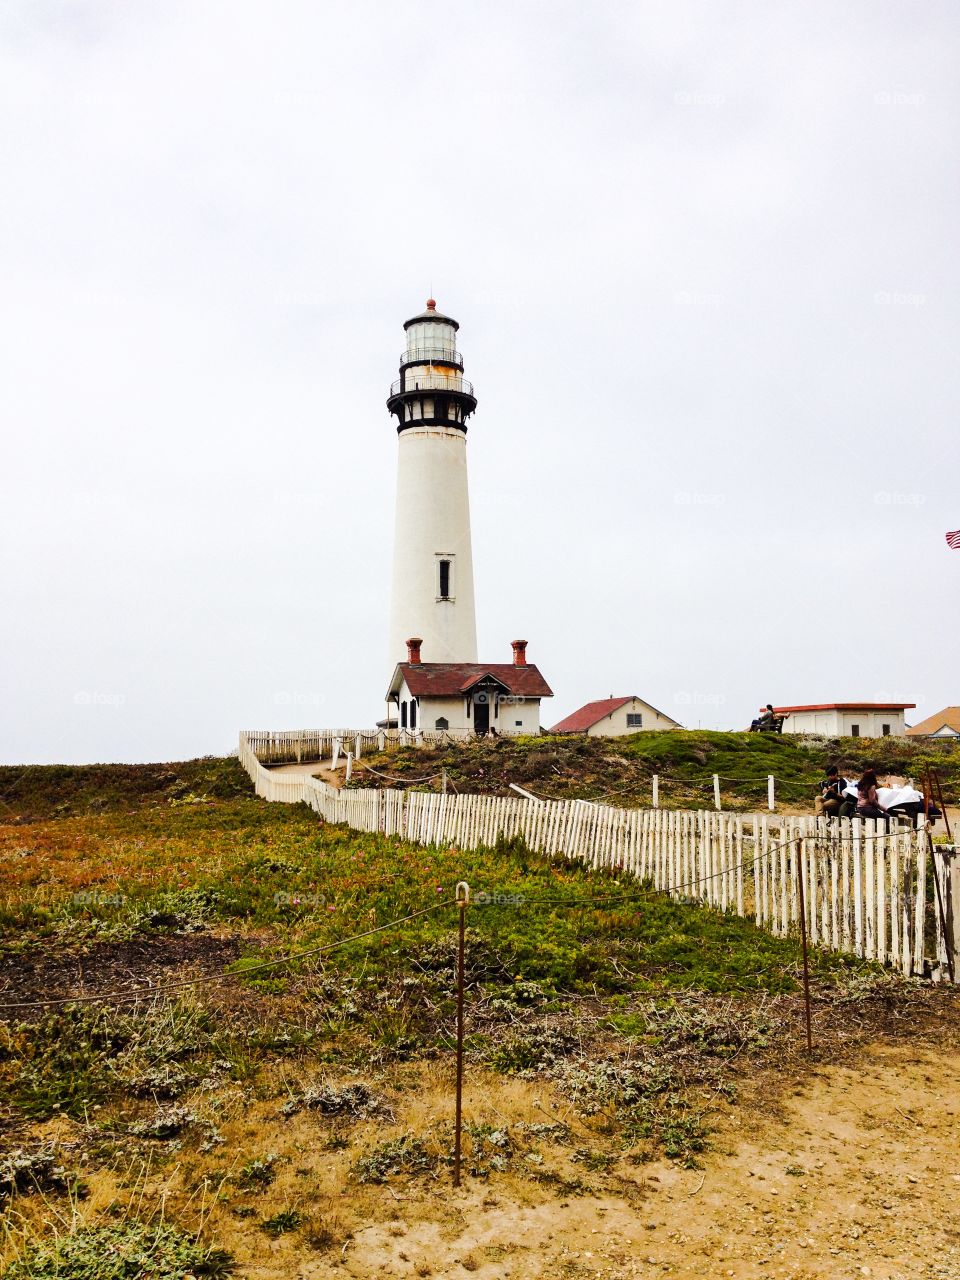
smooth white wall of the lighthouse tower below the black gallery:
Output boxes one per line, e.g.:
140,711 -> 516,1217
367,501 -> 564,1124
388,428 -> 476,668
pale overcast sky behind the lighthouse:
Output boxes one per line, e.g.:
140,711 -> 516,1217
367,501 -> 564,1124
0,0 -> 960,763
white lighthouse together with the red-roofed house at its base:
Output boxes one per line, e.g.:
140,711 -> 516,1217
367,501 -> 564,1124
380,298 -> 553,736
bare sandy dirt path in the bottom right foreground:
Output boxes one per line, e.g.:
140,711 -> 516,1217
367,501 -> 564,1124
305,1046 -> 960,1280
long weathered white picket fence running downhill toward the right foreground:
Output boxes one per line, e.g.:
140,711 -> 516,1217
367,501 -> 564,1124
239,733 -> 952,975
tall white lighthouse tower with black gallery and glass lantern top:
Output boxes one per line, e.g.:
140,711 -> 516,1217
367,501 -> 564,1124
387,298 -> 476,663
